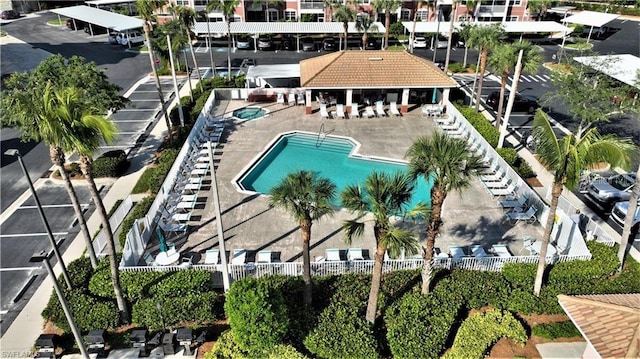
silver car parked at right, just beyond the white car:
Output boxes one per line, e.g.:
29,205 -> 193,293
586,173 -> 636,210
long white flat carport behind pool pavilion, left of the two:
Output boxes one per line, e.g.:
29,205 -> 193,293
193,22 -> 385,52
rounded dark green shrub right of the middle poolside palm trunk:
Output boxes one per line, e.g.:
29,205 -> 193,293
384,293 -> 461,358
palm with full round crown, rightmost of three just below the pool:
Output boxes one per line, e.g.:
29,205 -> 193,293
406,132 -> 482,294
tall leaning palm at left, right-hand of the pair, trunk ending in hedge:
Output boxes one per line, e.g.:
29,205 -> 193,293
53,87 -> 130,323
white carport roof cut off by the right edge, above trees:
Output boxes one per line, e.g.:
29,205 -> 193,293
573,54 -> 640,89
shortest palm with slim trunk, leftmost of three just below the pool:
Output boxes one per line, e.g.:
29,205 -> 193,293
269,171 -> 336,307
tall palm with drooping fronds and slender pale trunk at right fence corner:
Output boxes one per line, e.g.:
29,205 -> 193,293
533,110 -> 637,296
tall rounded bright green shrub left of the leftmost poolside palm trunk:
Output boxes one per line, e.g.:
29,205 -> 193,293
224,278 -> 289,352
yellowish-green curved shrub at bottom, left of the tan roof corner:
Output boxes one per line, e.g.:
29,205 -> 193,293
443,309 -> 527,359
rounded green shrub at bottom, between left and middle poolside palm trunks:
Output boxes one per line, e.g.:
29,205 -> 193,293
304,302 -> 378,359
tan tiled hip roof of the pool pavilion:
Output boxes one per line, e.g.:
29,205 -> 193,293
300,50 -> 457,89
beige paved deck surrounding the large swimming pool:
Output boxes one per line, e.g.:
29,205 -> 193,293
152,101 -> 543,264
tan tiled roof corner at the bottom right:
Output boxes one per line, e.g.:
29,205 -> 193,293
558,293 -> 640,358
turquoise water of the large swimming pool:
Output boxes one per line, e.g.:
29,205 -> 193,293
239,133 -> 431,207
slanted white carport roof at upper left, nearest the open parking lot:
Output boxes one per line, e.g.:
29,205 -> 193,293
51,5 -> 143,31
